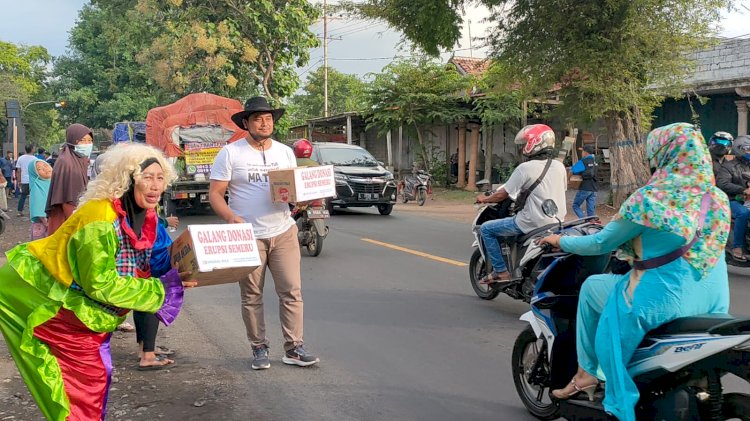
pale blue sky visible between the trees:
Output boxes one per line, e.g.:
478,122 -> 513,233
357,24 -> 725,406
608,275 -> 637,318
0,0 -> 750,78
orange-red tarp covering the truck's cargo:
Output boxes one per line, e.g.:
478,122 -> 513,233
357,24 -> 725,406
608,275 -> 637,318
146,93 -> 247,157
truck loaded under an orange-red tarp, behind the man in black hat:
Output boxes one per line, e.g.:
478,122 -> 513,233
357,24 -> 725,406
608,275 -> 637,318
146,93 -> 247,215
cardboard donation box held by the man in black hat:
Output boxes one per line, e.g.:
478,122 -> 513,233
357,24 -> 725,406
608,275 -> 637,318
268,165 -> 336,203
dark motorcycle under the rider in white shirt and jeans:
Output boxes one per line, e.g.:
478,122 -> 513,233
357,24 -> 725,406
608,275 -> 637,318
469,193 -> 601,303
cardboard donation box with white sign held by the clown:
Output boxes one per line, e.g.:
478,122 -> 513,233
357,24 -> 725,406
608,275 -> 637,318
171,224 -> 260,286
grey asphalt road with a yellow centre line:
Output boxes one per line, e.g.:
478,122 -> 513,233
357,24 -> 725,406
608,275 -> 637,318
172,209 -> 750,420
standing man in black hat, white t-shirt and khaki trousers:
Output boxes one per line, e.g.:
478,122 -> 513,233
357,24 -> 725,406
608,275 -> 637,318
209,97 -> 319,370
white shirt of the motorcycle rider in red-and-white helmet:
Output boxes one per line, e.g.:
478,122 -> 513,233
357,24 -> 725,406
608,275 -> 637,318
503,159 -> 568,233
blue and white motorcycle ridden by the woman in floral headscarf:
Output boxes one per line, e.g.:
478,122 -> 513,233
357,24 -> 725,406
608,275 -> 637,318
512,202 -> 750,421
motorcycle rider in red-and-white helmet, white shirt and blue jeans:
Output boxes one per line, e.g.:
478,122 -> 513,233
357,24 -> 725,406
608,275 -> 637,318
476,124 -> 567,285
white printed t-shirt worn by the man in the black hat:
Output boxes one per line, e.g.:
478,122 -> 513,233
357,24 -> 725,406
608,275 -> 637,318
211,139 -> 297,238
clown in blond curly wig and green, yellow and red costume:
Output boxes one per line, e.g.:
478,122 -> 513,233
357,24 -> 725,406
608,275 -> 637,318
0,144 -> 195,420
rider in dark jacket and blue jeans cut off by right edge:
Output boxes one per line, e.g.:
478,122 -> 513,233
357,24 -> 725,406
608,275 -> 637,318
716,135 -> 750,262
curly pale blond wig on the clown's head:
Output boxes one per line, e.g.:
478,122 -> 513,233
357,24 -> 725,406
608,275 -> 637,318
78,143 -> 177,207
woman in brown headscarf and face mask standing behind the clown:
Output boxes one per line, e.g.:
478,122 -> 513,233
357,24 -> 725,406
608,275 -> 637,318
45,123 -> 94,234
